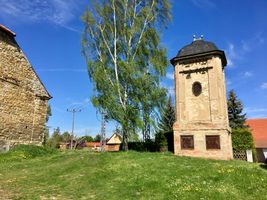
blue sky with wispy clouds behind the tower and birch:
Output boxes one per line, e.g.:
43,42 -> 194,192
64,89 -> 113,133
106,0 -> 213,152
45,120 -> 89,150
0,0 -> 267,136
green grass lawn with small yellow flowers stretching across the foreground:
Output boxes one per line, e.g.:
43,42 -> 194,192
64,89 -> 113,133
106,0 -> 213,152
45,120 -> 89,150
0,150 -> 267,200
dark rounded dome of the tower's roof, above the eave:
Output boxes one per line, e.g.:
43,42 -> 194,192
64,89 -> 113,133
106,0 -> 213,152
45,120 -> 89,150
176,40 -> 218,57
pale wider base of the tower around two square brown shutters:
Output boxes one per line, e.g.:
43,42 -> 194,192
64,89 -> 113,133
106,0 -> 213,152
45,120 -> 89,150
174,129 -> 233,160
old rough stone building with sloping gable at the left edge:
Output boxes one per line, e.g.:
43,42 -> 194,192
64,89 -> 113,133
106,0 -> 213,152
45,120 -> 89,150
0,25 -> 51,149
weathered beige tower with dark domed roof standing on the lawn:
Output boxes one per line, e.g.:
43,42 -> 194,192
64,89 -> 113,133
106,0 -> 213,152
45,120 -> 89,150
171,37 -> 233,160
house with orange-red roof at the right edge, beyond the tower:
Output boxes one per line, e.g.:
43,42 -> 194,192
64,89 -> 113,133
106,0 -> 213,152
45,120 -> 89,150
246,118 -> 267,162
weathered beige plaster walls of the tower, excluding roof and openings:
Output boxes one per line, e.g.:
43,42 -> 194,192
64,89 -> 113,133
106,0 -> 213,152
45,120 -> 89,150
173,56 -> 233,159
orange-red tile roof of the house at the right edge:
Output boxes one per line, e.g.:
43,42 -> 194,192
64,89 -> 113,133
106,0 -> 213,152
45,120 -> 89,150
246,118 -> 267,148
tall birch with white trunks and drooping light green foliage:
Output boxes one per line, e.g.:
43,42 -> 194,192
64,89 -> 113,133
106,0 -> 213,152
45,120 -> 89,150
82,0 -> 170,150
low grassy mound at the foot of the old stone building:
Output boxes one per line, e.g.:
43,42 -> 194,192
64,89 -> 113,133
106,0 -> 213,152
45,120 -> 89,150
0,145 -> 57,162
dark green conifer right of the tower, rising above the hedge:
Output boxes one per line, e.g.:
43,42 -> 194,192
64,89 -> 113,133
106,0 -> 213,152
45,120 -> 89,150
227,90 -> 247,128
